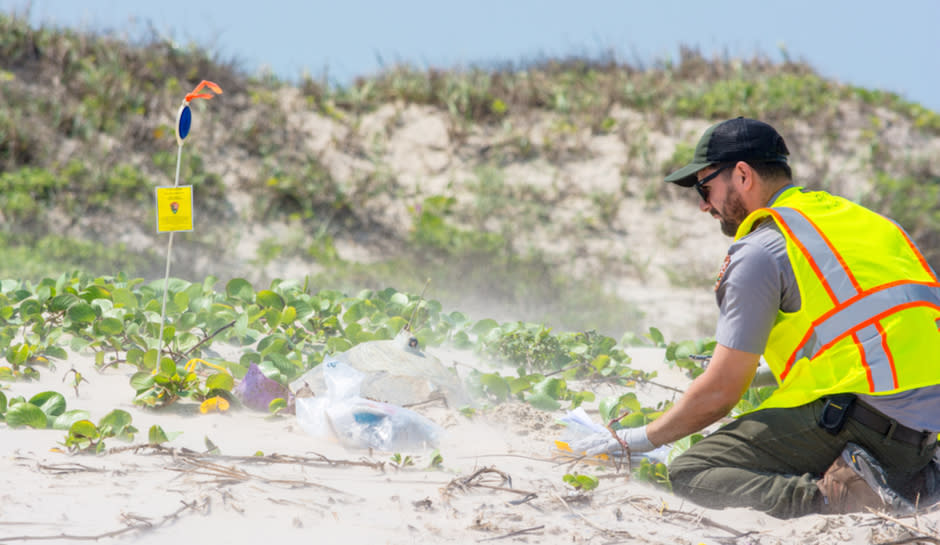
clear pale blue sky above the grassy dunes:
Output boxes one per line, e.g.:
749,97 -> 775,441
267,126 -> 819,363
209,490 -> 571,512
0,0 -> 940,111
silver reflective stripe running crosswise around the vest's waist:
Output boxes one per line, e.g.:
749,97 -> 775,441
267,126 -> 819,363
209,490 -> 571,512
798,284 -> 940,359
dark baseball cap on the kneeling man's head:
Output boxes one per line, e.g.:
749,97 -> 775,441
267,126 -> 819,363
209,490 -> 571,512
666,117 -> 790,187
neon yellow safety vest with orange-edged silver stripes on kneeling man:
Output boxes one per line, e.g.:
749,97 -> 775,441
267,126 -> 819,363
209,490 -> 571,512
735,187 -> 940,409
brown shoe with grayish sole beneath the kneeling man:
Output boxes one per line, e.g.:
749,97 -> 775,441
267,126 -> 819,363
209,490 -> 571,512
816,443 -> 913,515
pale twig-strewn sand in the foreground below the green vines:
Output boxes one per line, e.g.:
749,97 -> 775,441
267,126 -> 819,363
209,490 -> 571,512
0,349 -> 940,545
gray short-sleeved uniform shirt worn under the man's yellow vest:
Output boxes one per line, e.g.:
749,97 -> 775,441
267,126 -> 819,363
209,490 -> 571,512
715,186 -> 940,431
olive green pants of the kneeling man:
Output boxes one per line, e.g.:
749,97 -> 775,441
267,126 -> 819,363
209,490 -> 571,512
669,400 -> 936,518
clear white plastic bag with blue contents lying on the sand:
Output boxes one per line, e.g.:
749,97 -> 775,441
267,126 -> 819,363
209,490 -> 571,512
296,361 -> 443,451
